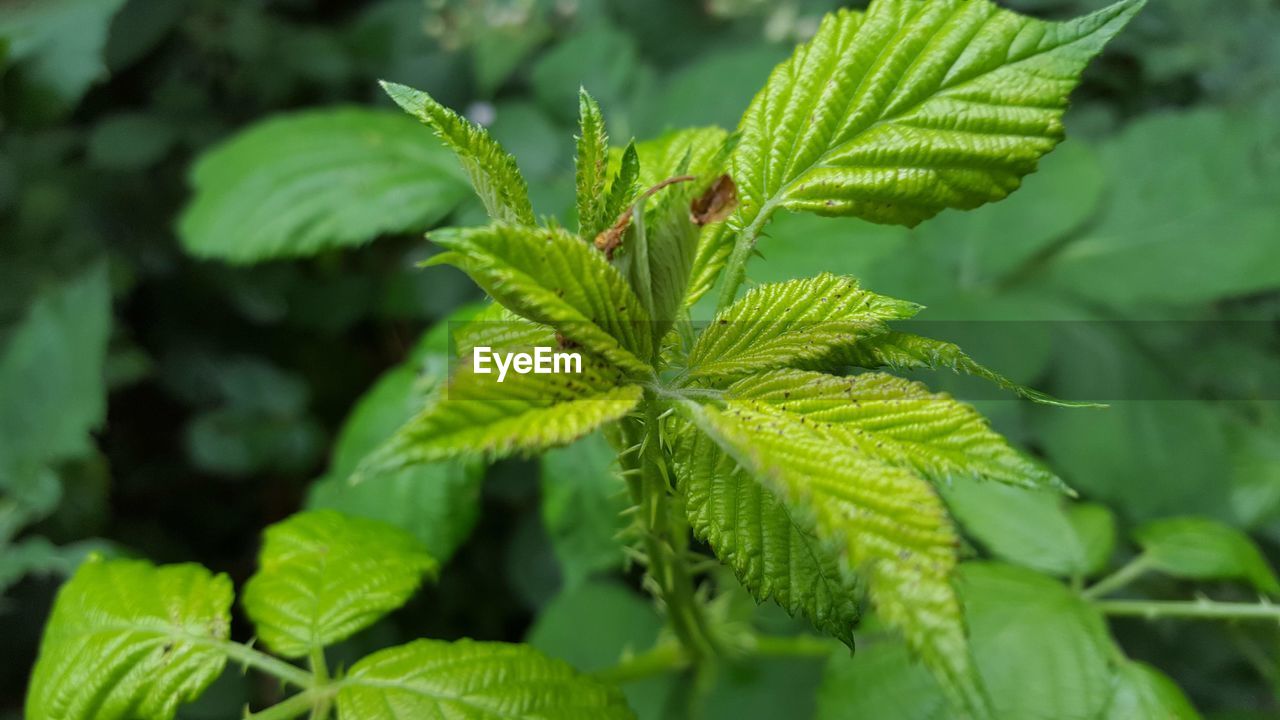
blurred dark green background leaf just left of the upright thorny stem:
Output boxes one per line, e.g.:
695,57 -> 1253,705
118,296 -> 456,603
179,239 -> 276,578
541,433 -> 630,587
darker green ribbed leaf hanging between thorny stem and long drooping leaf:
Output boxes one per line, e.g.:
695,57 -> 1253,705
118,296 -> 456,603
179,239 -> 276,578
676,428 -> 860,640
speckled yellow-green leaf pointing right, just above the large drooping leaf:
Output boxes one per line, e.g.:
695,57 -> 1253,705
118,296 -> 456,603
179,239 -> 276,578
726,370 -> 1068,489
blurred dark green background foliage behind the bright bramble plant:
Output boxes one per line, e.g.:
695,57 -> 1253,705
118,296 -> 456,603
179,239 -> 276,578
0,0 -> 1280,720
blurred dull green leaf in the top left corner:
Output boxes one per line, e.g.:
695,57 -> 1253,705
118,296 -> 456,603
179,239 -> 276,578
0,0 -> 124,108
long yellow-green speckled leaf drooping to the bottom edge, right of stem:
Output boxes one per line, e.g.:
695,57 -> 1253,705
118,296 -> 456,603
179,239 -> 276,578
681,401 -> 989,716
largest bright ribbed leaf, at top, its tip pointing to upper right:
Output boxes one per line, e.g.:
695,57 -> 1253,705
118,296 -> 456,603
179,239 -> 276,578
726,0 -> 1143,299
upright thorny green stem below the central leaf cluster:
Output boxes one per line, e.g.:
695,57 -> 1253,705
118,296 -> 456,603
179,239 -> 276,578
621,392 -> 717,665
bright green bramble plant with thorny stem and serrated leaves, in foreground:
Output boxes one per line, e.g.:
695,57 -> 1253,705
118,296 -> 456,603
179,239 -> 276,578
27,0 -> 1277,720
